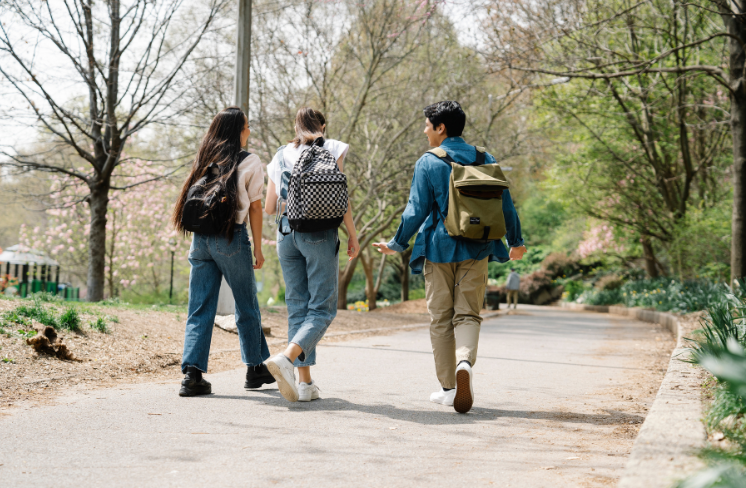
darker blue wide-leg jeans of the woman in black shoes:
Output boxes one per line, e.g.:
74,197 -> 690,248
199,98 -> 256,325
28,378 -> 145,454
181,224 -> 269,372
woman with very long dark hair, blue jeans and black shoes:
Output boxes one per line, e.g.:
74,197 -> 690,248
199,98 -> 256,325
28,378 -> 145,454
172,107 -> 275,396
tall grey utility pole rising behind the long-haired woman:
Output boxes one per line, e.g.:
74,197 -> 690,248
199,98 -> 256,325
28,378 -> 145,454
218,0 -> 250,315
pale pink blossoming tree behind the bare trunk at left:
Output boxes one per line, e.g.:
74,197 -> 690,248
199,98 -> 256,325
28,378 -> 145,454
20,160 -> 189,297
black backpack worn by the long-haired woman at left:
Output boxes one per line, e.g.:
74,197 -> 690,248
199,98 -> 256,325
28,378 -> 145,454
181,151 -> 249,236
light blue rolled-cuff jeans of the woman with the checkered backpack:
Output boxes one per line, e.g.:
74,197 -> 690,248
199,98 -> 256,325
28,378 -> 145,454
277,229 -> 339,367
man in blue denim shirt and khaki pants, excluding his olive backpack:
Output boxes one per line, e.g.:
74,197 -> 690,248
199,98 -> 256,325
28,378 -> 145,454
373,101 -> 526,413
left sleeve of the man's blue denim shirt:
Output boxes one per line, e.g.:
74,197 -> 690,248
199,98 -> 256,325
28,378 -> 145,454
387,156 -> 434,252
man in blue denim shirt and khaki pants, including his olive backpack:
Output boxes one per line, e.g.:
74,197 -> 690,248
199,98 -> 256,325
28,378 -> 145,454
373,101 -> 526,413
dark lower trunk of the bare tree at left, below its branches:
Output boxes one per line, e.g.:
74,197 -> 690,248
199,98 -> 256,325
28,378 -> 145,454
86,180 -> 109,302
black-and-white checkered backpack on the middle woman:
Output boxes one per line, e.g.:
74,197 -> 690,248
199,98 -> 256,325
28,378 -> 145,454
287,137 -> 347,232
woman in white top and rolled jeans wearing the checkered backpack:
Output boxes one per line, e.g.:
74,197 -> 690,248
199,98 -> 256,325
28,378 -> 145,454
264,107 -> 360,402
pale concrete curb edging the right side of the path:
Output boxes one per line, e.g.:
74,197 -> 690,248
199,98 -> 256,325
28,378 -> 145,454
562,303 -> 707,488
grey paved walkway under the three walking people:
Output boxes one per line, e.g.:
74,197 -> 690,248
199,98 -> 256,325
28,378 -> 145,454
0,307 -> 664,488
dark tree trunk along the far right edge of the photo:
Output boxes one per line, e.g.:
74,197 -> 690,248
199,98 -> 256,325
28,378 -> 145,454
720,2 -> 746,284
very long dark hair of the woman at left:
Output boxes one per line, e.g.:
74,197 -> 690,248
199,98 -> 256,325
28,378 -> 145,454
171,107 -> 247,240
